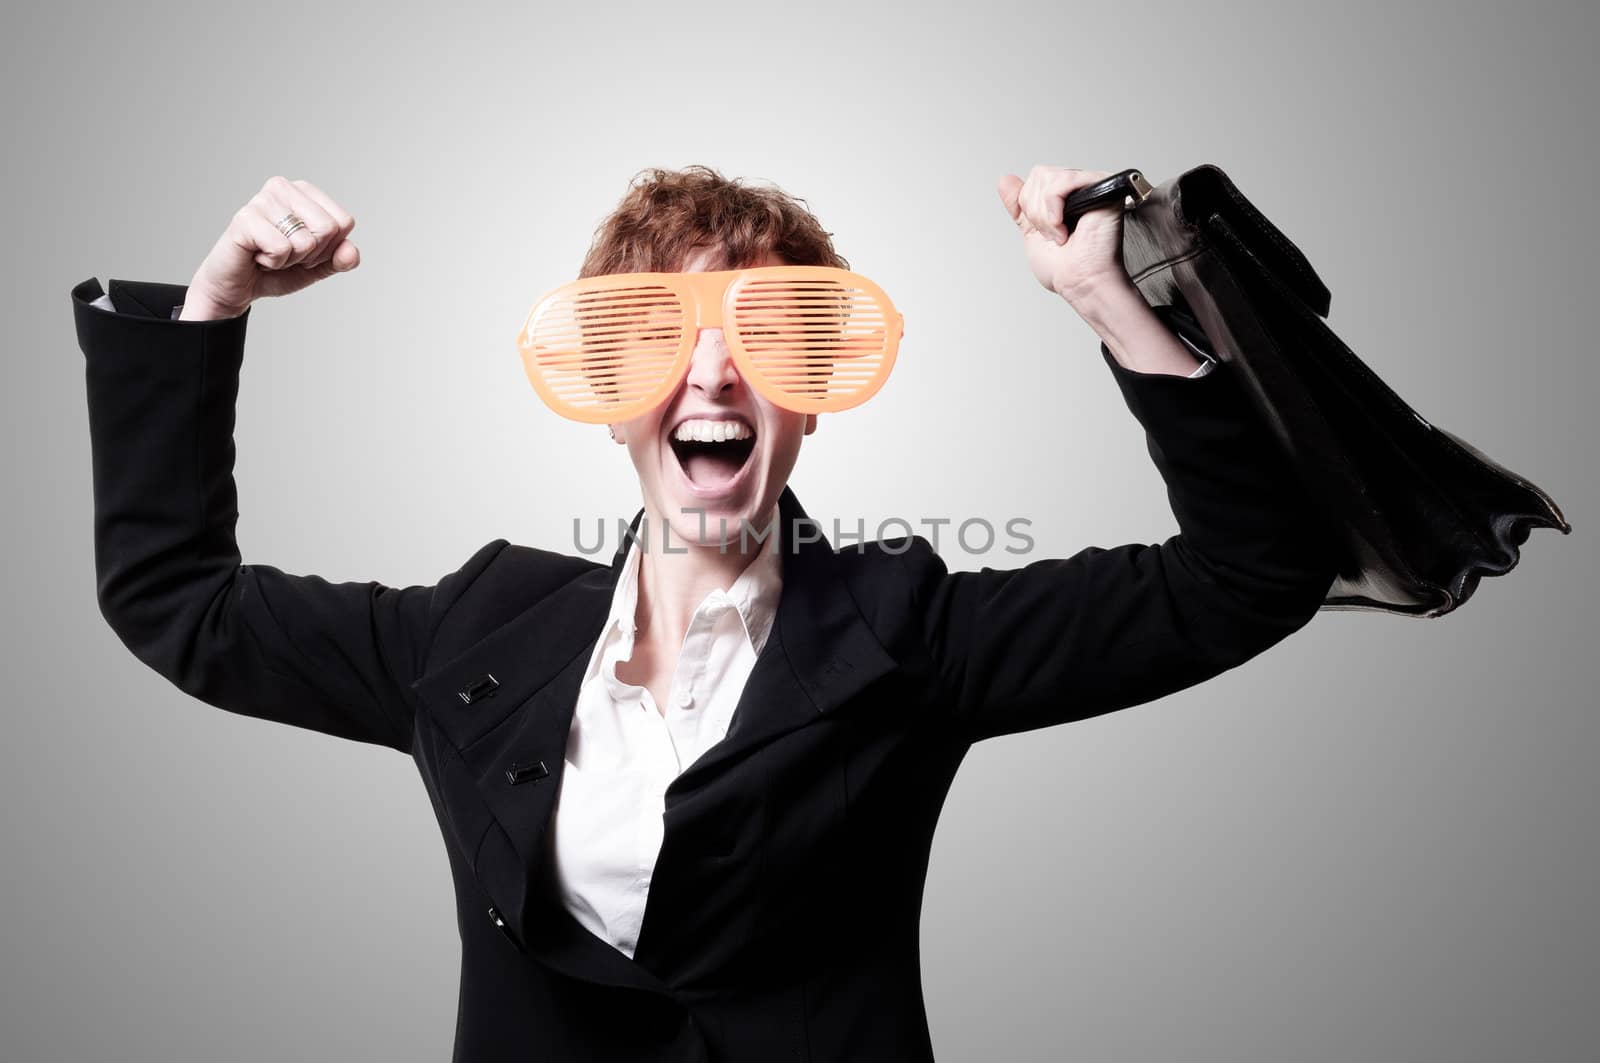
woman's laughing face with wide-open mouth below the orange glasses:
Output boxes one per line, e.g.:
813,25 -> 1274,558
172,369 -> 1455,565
613,248 -> 816,549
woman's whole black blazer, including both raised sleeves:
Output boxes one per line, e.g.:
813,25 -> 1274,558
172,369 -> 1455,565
72,279 -> 1336,1063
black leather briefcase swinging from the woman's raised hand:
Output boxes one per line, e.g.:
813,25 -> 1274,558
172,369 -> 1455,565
1094,165 -> 1571,616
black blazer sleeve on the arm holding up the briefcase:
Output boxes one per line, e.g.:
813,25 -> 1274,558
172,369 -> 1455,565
899,332 -> 1339,741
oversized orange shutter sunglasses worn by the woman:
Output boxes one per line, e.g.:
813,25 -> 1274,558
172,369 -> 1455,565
517,266 -> 906,424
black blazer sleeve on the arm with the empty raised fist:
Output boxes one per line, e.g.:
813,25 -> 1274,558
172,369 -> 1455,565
72,277 -> 506,752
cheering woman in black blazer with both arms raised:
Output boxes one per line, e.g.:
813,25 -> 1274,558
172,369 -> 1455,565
74,166 -> 1334,1061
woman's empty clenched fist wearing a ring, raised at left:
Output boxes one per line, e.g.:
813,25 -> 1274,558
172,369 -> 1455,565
179,178 -> 362,320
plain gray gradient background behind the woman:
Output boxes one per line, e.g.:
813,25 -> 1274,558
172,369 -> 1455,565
0,2 -> 1600,1063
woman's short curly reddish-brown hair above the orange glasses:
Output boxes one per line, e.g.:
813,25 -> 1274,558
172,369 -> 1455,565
578,165 -> 850,277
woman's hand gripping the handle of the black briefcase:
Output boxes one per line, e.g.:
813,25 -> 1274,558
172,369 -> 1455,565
995,166 -> 1133,307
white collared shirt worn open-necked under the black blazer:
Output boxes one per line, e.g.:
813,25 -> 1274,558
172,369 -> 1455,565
549,515 -> 782,957
